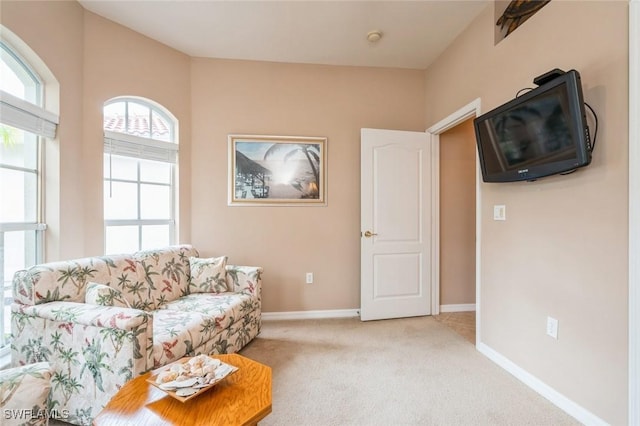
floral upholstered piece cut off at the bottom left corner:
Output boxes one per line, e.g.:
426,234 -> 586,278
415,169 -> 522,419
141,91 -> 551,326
0,362 -> 52,426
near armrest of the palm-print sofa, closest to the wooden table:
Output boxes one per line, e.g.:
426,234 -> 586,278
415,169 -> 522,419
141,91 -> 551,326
11,301 -> 153,424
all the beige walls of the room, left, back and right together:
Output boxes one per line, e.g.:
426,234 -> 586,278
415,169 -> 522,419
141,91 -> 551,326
0,0 -> 628,424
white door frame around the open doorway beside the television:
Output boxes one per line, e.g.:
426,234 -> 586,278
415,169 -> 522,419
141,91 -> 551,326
427,98 -> 482,347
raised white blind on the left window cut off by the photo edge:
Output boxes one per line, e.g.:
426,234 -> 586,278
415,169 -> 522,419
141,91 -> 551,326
0,90 -> 59,139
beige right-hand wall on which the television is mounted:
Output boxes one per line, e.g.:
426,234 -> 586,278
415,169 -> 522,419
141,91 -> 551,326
425,1 -> 628,424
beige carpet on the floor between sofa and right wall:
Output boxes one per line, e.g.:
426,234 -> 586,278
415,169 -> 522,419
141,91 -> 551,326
241,317 -> 579,426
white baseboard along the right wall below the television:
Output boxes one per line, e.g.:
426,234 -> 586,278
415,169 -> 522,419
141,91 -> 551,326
476,343 -> 609,426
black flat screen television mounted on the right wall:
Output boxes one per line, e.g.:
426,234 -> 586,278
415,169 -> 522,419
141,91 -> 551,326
474,70 -> 592,182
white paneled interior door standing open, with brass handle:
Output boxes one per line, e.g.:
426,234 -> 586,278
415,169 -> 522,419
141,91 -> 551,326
360,129 -> 431,321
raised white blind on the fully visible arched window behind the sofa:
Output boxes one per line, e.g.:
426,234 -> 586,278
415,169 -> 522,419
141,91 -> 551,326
104,131 -> 178,163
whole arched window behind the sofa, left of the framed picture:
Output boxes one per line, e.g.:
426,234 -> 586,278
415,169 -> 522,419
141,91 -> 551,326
103,97 -> 178,253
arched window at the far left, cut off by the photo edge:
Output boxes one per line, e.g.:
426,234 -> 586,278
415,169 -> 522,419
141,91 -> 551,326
0,35 -> 58,357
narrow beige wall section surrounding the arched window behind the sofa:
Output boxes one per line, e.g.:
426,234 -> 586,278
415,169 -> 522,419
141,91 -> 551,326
83,12 -> 191,255
